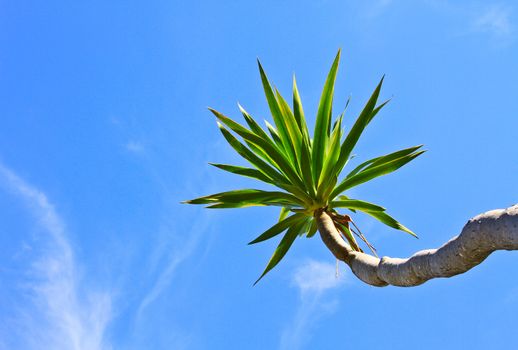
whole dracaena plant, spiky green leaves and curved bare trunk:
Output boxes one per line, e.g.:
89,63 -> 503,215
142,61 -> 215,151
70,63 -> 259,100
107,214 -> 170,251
185,51 -> 518,286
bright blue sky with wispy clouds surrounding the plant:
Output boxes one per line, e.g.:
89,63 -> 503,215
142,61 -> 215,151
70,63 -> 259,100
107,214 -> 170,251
0,0 -> 518,350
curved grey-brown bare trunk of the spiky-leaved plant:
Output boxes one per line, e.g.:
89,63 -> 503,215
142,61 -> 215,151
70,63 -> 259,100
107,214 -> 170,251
315,204 -> 518,287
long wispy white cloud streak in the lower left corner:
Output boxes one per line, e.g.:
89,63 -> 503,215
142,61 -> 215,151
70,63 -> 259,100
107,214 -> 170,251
0,164 -> 111,350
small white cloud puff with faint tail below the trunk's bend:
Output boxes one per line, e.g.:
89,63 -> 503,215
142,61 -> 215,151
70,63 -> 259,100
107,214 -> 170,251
279,260 -> 347,350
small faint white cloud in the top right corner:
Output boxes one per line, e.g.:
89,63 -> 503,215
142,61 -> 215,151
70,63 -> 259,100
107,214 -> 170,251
473,5 -> 513,37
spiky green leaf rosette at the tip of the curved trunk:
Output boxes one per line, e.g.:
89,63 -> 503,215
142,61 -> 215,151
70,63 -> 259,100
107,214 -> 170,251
185,51 -> 424,283
